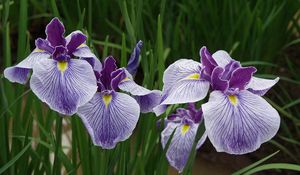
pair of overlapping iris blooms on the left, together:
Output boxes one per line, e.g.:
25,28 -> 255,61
4,18 -> 161,149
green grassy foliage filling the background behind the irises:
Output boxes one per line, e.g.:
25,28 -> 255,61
0,0 -> 300,175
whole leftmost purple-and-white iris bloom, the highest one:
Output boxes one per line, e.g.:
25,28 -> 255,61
4,18 -> 101,115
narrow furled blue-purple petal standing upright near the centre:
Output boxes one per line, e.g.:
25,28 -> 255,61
126,41 -> 143,75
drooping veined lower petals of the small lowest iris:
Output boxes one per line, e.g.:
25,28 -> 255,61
161,122 -> 199,173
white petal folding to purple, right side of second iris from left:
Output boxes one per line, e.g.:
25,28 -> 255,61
119,76 -> 161,113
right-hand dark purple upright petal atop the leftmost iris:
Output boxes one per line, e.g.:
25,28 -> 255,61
67,32 -> 86,54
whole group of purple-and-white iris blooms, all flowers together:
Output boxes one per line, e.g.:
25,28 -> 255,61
4,18 -> 280,172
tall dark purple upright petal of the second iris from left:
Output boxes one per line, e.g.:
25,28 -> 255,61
100,56 -> 118,89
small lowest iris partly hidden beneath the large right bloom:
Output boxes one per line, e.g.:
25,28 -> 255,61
161,103 -> 207,173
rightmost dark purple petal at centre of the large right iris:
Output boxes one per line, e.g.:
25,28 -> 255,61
229,67 -> 256,90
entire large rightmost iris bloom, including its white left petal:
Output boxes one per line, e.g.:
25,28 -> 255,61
154,47 -> 280,154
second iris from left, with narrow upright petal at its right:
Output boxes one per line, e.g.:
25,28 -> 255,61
78,42 -> 161,149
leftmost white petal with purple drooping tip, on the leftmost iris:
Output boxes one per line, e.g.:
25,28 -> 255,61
4,49 -> 50,84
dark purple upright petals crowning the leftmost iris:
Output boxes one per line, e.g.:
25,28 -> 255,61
35,18 -> 86,61
